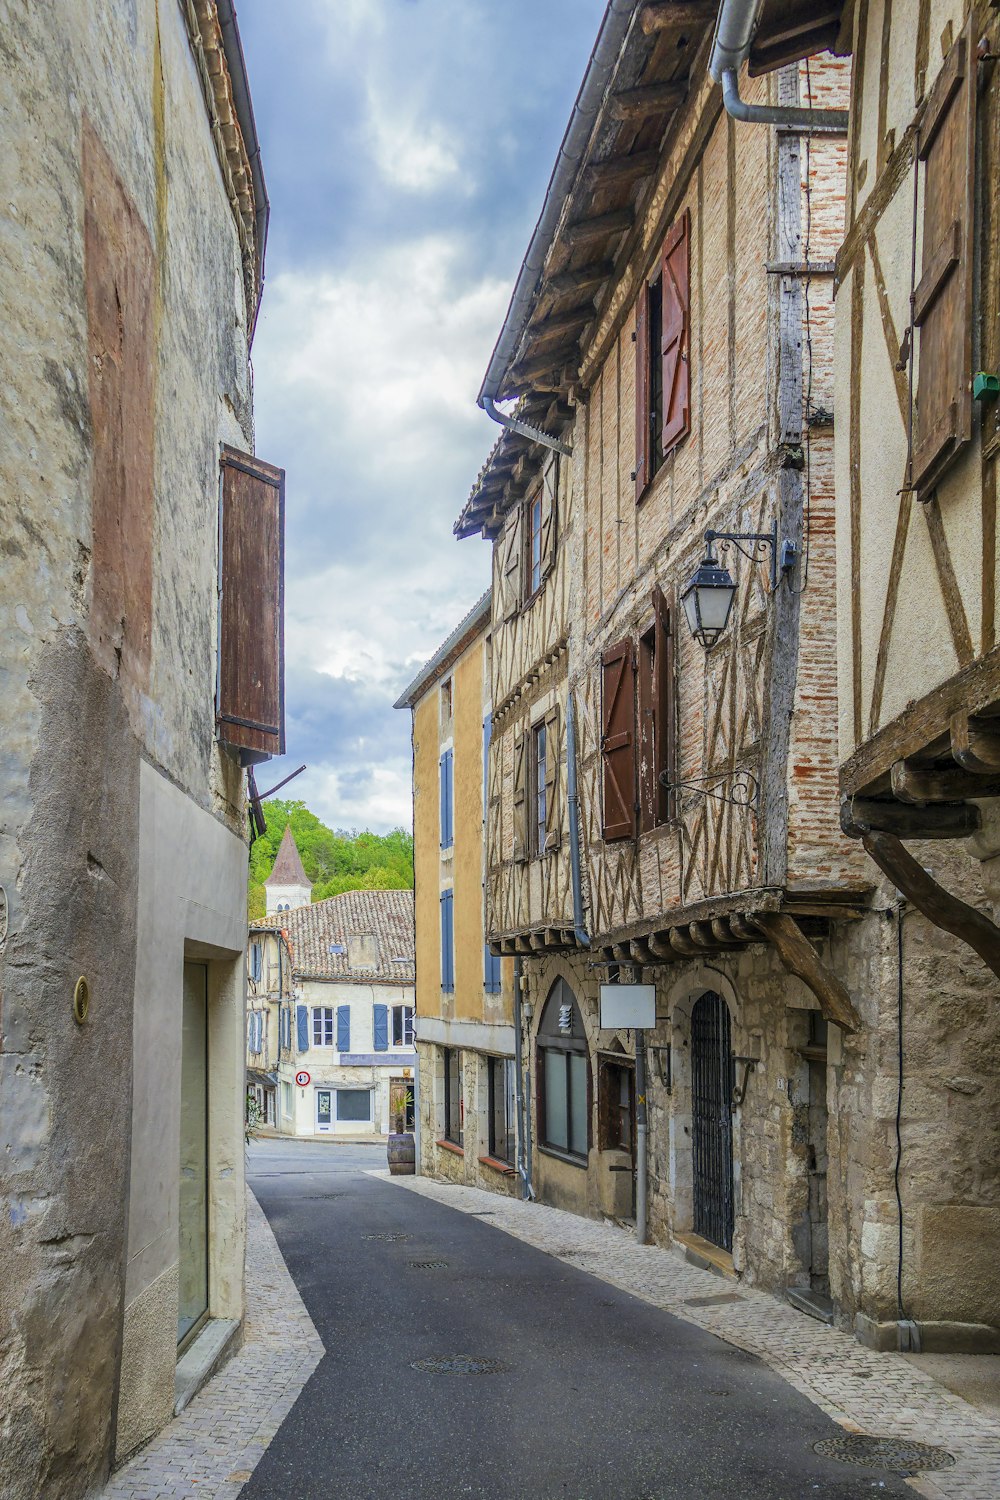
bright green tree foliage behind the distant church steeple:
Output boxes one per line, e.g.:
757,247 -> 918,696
249,798 -> 414,921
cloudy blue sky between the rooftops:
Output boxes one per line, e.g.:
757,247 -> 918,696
238,0 -> 604,833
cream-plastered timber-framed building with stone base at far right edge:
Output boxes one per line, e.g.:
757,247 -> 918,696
835,0 -> 1000,1349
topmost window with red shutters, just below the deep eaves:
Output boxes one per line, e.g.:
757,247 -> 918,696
634,210 -> 691,500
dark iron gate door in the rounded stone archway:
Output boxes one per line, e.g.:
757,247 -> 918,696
691,990 -> 733,1250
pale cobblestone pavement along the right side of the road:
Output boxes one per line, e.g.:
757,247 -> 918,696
386,1172 -> 1000,1500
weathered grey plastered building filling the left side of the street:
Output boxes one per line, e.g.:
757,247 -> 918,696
0,0 -> 283,1500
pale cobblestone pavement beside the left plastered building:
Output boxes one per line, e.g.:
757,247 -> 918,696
102,1191 -> 324,1500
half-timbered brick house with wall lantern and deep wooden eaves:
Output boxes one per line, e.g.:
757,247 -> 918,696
456,0 -> 996,1344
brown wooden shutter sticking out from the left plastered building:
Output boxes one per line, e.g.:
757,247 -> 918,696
216,447 -> 285,761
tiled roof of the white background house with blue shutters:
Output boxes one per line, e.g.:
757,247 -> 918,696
269,891 -> 417,984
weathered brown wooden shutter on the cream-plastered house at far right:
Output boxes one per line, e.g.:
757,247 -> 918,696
912,18 -> 976,498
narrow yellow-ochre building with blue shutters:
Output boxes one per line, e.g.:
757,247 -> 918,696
396,591 -> 526,1193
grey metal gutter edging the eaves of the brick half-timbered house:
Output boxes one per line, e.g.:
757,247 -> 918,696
478,0 -> 636,455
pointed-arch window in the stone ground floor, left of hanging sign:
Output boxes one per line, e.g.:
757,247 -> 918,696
535,980 -> 591,1167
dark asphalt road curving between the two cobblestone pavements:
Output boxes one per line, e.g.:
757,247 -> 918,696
241,1142 -> 913,1500
